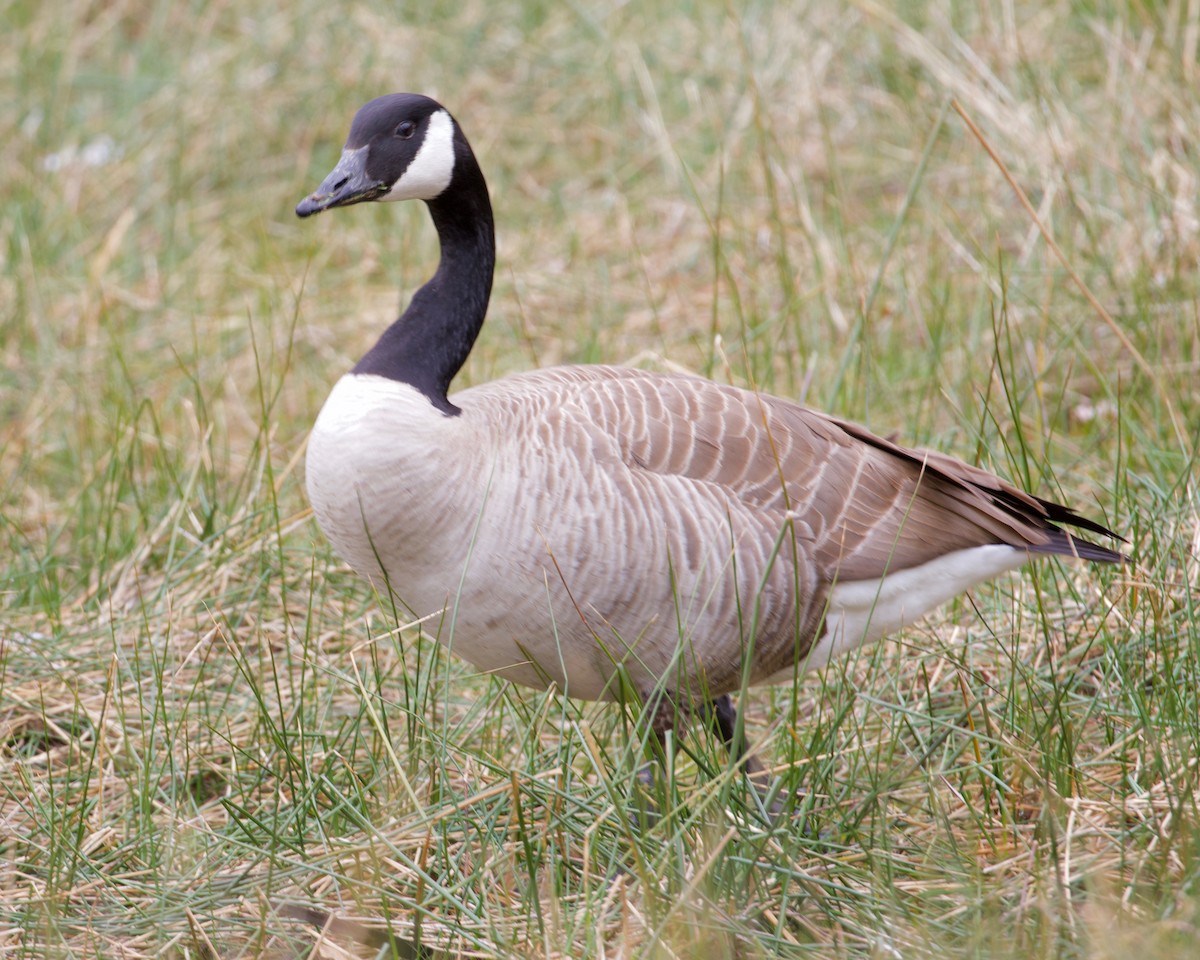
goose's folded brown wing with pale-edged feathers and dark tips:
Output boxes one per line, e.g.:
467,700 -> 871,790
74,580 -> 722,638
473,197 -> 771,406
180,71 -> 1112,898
525,367 -> 1122,580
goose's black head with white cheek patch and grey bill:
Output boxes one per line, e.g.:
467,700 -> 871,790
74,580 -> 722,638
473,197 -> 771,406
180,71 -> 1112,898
296,94 -> 466,217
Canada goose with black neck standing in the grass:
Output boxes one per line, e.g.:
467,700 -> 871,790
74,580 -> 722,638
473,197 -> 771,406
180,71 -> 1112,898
296,94 -> 1124,777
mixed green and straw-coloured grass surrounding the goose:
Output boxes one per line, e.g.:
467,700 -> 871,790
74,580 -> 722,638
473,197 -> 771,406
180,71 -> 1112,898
0,0 -> 1200,958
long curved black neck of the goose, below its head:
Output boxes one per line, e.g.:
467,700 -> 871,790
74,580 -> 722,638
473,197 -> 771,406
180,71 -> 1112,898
354,156 -> 496,415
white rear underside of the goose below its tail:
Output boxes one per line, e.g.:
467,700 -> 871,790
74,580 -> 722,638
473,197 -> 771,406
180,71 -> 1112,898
801,544 -> 1030,679
